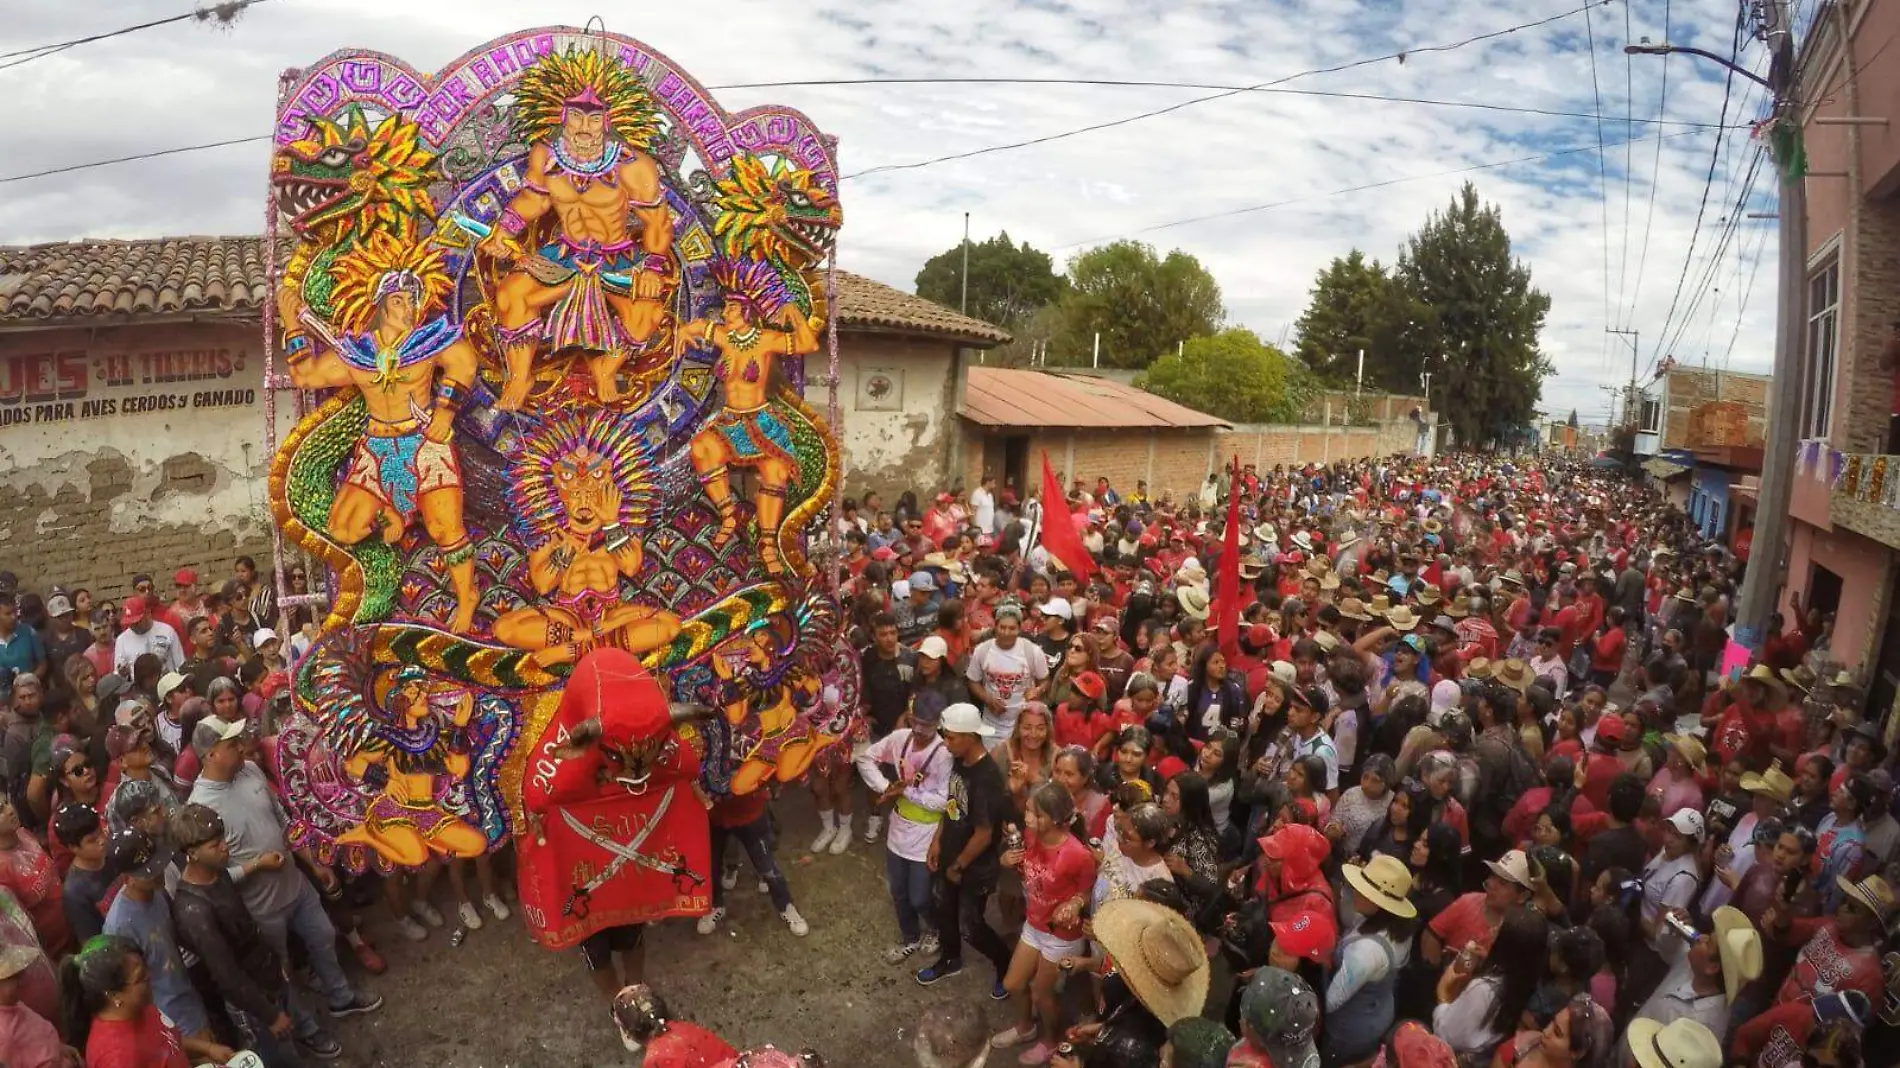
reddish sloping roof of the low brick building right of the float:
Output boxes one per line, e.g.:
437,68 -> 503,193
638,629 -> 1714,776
958,367 -> 1229,429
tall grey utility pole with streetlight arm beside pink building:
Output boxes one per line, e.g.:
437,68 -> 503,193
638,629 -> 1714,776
1623,0 -> 1807,652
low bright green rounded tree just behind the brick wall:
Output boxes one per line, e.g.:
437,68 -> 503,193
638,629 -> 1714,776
1134,327 -> 1317,422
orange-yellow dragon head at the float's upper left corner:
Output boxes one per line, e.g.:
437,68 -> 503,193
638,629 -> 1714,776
272,105 -> 435,241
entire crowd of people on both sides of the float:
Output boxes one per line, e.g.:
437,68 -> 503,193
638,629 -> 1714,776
0,454 -> 1900,1068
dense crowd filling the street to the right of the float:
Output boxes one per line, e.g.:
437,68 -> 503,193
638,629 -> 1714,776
811,456 -> 1900,1068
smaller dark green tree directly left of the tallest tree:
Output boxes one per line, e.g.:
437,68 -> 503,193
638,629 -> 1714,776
1294,249 -> 1419,383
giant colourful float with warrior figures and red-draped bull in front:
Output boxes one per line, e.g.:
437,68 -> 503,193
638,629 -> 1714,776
266,29 -> 857,948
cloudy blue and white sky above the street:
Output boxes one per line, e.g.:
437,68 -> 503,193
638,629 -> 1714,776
0,0 -> 1775,422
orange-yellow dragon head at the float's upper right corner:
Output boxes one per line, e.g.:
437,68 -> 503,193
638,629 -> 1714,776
713,154 -> 844,270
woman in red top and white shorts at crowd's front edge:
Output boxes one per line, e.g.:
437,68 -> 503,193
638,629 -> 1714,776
990,783 -> 1096,1064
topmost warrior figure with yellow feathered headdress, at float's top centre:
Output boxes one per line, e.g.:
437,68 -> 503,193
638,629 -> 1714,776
481,48 -> 678,410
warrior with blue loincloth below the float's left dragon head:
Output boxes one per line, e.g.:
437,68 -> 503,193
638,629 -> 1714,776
285,234 -> 481,635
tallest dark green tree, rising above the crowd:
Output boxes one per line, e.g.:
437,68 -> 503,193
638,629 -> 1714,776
1393,182 -> 1554,445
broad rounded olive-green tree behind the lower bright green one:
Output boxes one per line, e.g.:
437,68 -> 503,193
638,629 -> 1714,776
1048,241 -> 1227,369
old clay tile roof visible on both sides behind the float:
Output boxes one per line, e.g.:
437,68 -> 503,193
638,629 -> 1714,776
0,238 -> 1009,348
